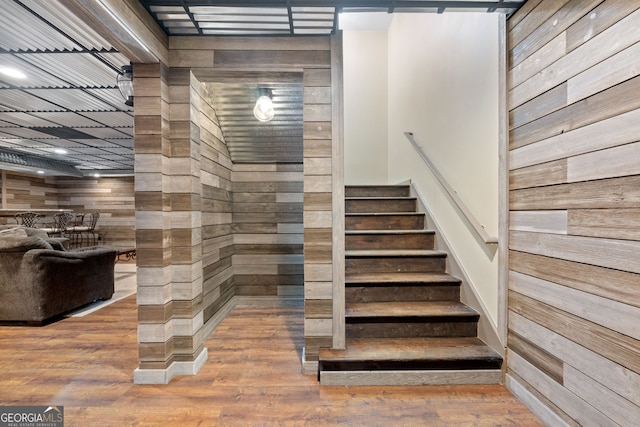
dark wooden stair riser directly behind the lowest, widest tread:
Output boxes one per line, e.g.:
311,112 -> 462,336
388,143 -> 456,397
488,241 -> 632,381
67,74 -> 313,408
345,319 -> 478,338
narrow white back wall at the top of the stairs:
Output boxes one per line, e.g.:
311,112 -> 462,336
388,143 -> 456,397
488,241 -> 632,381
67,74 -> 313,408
343,31 -> 388,184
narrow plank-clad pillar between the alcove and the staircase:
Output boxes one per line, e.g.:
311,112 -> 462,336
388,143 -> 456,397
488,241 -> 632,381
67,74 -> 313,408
302,64 -> 333,373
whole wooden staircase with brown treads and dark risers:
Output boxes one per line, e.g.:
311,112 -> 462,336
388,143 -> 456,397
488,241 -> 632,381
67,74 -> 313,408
319,186 -> 502,385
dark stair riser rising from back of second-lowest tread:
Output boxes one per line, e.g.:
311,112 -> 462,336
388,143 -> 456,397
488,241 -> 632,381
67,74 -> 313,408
345,285 -> 460,303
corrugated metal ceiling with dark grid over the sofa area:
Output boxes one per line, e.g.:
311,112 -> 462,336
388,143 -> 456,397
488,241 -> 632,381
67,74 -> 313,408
0,0 -> 133,175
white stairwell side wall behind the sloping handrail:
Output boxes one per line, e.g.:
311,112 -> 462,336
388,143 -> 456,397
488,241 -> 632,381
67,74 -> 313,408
388,13 -> 499,324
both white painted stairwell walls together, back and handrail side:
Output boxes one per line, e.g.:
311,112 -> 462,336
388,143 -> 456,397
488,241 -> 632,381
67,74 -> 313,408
343,13 -> 499,324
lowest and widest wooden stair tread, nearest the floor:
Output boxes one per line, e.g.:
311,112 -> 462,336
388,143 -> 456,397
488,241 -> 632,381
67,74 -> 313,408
320,337 -> 502,367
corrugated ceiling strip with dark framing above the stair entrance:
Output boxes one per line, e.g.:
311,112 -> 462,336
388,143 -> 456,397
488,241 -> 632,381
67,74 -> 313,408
140,0 -> 524,36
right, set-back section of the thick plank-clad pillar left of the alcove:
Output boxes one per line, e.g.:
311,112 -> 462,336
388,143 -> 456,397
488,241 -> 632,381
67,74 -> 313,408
169,69 -> 206,373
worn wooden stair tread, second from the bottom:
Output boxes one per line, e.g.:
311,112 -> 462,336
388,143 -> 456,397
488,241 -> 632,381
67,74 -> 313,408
345,301 -> 478,319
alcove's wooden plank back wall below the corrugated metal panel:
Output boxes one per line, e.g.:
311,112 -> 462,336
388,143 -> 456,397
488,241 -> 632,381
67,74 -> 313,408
232,162 -> 304,297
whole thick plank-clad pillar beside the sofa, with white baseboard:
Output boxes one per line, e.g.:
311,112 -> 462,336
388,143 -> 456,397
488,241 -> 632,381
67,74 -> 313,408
134,64 -> 207,384
